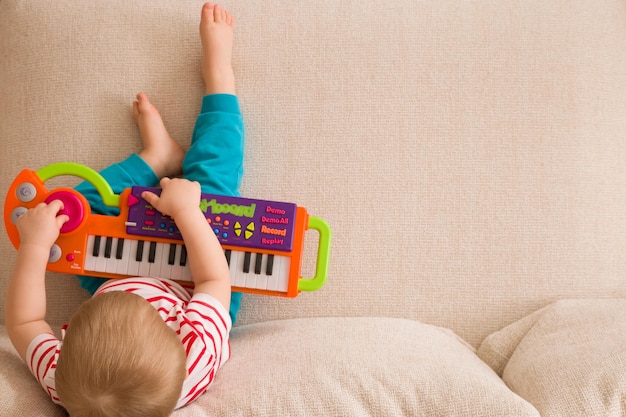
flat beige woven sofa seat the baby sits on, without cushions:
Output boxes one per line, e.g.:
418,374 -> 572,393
0,0 -> 626,346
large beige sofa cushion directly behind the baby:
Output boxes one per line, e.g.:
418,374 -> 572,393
0,318 -> 539,417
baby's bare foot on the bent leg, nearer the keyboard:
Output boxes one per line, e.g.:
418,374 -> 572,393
133,93 -> 185,178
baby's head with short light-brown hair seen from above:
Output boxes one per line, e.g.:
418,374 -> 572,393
55,291 -> 187,417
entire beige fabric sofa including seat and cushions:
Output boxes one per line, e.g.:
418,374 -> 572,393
0,0 -> 626,417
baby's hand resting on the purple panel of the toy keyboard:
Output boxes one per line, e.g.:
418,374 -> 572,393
141,177 -> 200,219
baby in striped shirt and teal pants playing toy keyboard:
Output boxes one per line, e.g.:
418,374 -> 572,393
5,3 -> 244,417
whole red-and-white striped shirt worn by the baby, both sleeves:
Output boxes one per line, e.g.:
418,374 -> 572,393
26,278 -> 232,408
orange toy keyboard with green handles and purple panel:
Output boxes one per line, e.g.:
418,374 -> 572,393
4,162 -> 331,297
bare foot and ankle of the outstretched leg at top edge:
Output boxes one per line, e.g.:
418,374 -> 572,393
200,3 -> 235,94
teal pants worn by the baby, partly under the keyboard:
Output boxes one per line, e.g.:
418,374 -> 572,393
76,94 -> 244,323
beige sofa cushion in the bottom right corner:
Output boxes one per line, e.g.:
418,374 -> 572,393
478,299 -> 626,417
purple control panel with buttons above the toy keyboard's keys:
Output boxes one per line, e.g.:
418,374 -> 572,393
126,187 -> 296,252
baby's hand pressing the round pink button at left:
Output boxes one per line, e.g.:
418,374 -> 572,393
16,200 -> 69,249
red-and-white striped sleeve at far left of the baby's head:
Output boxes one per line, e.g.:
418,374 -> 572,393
26,333 -> 63,406
